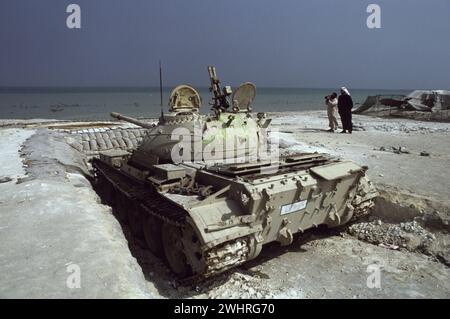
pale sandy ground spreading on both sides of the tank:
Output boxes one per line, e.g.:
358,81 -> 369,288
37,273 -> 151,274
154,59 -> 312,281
0,112 -> 450,298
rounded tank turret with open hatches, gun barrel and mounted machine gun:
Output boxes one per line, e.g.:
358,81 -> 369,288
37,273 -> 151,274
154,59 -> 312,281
111,66 -> 270,168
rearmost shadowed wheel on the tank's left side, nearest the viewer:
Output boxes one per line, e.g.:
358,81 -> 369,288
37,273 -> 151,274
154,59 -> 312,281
162,224 -> 192,278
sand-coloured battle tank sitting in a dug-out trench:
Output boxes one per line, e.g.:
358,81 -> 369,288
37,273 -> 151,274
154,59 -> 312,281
92,67 -> 377,278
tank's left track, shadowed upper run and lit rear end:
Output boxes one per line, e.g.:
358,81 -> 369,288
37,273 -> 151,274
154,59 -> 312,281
93,159 -> 249,285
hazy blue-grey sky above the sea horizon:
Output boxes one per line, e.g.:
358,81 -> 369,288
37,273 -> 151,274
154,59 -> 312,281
0,0 -> 450,89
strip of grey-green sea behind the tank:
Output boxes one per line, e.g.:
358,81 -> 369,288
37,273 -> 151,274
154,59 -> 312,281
0,87 -> 411,121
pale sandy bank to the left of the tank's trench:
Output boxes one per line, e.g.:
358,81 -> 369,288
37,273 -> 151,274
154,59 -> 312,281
0,129 -> 154,298
